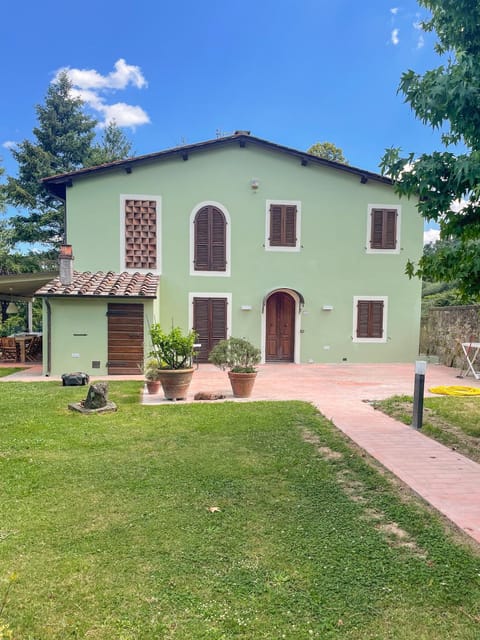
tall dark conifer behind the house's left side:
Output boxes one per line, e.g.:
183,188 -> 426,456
5,73 -> 97,247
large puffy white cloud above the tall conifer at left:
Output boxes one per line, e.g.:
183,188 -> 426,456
55,58 -> 150,128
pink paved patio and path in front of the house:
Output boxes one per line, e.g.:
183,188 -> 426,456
0,363 -> 480,542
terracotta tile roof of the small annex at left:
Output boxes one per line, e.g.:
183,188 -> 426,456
35,271 -> 160,298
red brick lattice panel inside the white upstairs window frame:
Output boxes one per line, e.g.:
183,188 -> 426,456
125,200 -> 157,269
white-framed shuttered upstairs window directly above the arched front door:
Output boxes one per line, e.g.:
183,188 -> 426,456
265,200 -> 300,251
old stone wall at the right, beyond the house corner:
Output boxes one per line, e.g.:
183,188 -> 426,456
420,305 -> 480,368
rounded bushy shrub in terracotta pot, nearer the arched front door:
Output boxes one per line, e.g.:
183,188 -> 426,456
208,337 -> 260,398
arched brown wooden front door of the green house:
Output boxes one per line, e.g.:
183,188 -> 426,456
265,291 -> 295,362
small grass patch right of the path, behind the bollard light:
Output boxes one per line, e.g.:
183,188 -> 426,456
375,396 -> 480,463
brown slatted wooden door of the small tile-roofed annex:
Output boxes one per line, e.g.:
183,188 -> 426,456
107,303 -> 143,375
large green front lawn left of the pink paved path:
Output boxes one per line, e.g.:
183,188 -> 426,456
0,382 -> 480,640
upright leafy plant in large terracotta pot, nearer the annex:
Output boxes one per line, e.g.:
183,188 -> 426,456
150,324 -> 197,400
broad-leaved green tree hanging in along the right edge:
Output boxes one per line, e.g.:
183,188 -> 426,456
380,0 -> 480,296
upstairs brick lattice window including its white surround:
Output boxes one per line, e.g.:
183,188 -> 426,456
121,196 -> 160,271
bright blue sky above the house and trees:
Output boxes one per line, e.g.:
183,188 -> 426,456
0,0 -> 441,239
